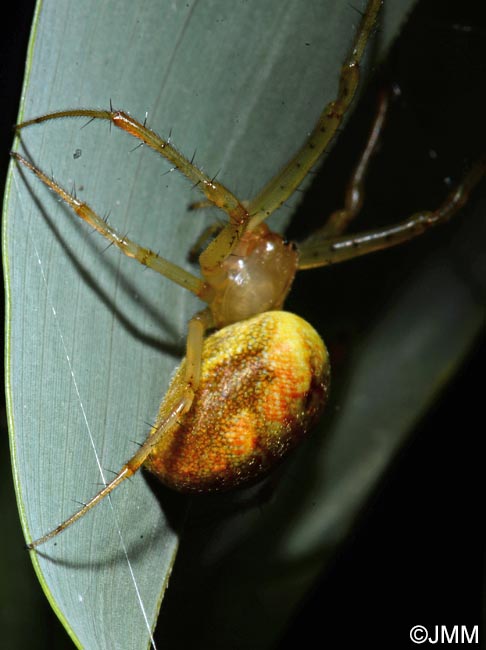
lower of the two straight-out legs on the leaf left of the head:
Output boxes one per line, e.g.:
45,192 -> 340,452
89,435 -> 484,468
11,152 -> 205,300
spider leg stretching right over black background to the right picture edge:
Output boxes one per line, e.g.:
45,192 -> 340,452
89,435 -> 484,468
298,158 -> 486,270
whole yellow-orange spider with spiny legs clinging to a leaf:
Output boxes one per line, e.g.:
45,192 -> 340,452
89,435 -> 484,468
12,0 -> 485,549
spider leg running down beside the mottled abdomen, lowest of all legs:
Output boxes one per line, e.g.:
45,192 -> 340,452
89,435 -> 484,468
27,309 -> 212,550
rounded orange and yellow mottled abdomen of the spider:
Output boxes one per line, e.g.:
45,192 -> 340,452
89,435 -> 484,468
144,311 -> 330,492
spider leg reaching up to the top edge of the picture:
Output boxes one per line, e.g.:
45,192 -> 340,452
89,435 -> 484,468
248,0 -> 382,229
